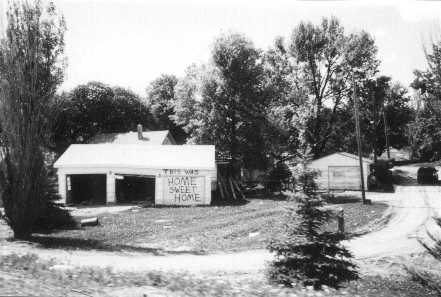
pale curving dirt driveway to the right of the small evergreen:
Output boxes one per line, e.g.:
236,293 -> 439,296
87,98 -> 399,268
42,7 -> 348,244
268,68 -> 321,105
348,186 -> 441,259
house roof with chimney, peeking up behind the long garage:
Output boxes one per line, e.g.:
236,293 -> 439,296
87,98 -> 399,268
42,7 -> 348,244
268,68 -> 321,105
89,130 -> 174,145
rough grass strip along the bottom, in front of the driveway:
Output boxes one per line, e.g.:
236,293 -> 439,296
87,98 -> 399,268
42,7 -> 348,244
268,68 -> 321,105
0,254 -> 437,297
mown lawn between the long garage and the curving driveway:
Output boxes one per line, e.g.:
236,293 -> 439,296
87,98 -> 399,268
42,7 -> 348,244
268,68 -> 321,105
30,199 -> 387,253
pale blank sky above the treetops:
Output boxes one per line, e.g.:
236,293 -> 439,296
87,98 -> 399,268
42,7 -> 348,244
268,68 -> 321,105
0,0 -> 441,96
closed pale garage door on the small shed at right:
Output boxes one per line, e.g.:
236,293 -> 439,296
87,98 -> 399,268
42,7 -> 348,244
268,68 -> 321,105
328,166 -> 361,190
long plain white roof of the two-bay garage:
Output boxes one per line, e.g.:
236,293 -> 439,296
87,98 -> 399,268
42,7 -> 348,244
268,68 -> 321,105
54,143 -> 216,170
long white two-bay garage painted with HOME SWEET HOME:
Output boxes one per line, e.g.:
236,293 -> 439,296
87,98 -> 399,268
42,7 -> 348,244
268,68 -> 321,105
54,144 -> 216,205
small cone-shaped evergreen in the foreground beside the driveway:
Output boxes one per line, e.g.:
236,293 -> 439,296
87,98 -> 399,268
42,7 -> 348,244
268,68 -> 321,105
268,170 -> 358,289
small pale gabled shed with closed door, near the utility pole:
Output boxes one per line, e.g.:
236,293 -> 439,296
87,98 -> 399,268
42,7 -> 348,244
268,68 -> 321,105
308,152 -> 372,190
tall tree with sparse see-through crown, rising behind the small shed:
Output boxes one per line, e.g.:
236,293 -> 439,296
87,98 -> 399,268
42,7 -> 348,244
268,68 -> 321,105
289,18 -> 379,157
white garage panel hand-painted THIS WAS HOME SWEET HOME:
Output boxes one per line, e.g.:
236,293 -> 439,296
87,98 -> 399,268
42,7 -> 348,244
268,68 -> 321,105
163,171 -> 205,205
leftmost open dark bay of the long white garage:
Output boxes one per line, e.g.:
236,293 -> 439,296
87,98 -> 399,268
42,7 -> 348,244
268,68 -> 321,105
67,174 -> 106,204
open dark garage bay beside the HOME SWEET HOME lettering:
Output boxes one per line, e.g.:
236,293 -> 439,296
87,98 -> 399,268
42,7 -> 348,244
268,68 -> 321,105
115,174 -> 155,203
